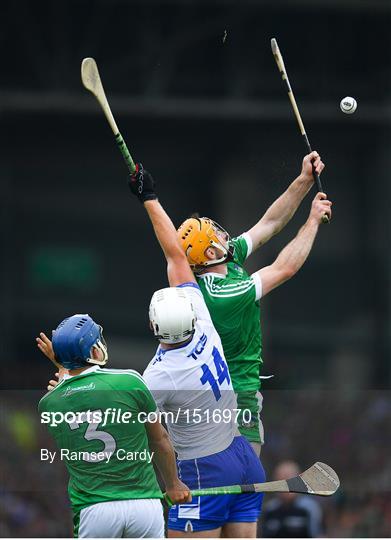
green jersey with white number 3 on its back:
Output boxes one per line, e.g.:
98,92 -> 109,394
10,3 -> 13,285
38,366 -> 162,512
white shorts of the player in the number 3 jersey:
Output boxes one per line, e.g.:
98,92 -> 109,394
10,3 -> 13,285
75,499 -> 164,538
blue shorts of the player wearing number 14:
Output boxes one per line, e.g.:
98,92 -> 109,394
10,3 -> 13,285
168,437 -> 265,532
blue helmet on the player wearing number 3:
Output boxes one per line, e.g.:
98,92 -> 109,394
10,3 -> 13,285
52,314 -> 108,369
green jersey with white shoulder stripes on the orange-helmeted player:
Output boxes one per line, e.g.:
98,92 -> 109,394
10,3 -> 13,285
197,235 -> 262,392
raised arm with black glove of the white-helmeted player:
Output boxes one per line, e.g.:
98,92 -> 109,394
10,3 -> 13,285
129,165 -> 195,287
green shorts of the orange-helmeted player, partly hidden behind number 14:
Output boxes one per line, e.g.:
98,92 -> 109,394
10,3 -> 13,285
236,390 -> 264,444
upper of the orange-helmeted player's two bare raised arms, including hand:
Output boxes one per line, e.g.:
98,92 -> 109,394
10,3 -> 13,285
248,152 -> 325,251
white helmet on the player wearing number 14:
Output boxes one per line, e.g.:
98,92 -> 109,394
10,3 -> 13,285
149,287 -> 196,344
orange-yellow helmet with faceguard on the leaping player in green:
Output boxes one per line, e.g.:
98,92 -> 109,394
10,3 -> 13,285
178,217 -> 232,271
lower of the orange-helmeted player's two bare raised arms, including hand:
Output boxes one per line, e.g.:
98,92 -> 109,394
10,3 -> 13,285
257,193 -> 331,296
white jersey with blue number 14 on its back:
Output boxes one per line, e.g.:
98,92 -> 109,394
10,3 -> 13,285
143,283 -> 239,460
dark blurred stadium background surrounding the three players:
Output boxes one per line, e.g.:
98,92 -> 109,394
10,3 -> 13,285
0,0 -> 391,537
